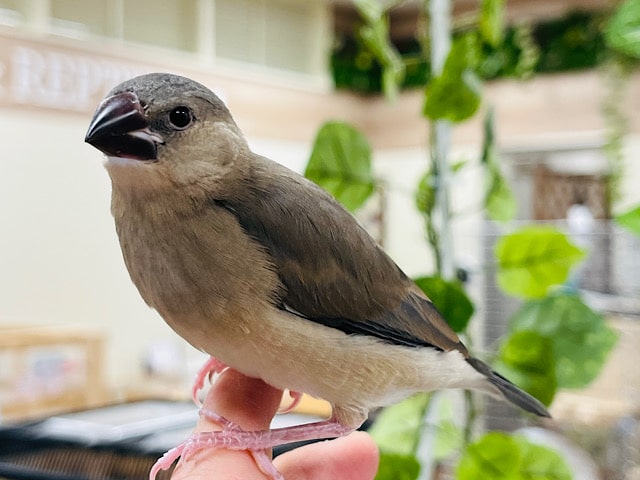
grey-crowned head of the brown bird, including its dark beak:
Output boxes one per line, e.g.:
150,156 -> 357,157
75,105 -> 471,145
85,73 -> 248,188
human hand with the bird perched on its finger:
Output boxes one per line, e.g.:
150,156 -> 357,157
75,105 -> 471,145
171,369 -> 378,480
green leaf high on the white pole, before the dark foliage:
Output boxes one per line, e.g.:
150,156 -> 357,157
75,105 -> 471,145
423,34 -> 482,122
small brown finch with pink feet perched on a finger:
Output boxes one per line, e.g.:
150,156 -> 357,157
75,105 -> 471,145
85,73 -> 550,478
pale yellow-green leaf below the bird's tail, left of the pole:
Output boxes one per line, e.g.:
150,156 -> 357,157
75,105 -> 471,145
368,393 -> 432,456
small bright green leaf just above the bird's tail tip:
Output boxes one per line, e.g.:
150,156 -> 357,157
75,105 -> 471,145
493,330 -> 557,405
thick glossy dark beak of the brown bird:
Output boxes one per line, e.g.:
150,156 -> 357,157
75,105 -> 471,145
84,92 -> 162,160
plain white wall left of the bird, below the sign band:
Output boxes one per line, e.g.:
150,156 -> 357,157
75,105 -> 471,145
0,110 -> 178,385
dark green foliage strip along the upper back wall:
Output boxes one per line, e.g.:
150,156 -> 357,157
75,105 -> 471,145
331,11 -> 609,94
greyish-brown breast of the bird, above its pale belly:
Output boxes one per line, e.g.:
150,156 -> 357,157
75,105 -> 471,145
116,195 -> 280,353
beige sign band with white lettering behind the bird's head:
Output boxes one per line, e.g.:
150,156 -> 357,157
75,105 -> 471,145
0,26 -> 330,144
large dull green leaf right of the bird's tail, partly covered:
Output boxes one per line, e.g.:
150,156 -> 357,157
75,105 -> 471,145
510,292 -> 617,390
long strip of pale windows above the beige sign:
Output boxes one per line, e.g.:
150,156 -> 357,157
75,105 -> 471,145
0,0 -> 330,73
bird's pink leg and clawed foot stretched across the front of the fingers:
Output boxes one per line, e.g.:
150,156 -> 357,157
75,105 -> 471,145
149,408 -> 355,480
